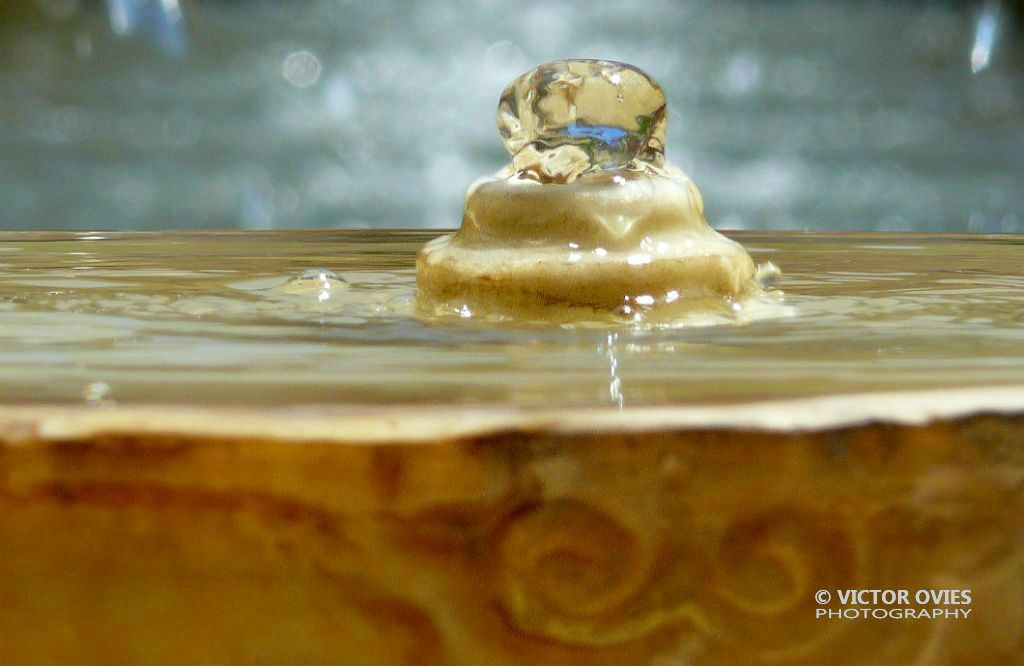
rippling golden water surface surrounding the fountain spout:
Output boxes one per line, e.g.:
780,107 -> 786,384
0,232 -> 1024,406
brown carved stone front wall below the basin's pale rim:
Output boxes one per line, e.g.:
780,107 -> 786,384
0,416 -> 1024,665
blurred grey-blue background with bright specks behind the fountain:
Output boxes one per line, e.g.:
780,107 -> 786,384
0,0 -> 1024,233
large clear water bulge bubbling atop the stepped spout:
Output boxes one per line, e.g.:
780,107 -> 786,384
498,59 -> 667,182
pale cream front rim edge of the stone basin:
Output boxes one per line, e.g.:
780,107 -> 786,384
0,384 -> 1024,446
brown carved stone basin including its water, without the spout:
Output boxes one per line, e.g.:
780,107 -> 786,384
0,231 -> 1024,664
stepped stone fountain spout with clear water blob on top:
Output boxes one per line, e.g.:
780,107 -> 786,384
417,60 -> 778,326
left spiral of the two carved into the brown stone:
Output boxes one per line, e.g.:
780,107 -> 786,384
496,500 -> 652,644
